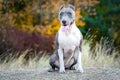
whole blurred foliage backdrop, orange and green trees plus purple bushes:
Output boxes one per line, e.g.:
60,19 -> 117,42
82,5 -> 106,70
0,0 -> 120,57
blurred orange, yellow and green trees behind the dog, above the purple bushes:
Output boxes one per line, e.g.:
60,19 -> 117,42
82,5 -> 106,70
0,0 -> 120,53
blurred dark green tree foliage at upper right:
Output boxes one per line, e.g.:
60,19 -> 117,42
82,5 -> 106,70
82,0 -> 120,50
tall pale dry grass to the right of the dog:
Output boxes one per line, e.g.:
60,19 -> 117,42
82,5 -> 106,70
82,38 -> 120,68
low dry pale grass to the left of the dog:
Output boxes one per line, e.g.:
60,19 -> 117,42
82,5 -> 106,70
0,50 -> 49,70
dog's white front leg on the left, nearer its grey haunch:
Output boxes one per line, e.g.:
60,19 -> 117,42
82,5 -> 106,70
58,49 -> 65,73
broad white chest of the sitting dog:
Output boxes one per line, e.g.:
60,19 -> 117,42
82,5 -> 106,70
58,29 -> 80,50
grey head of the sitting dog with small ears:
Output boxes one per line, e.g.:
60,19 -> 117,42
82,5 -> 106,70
59,5 -> 75,31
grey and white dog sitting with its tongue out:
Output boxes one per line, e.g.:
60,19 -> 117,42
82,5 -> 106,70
49,5 -> 83,73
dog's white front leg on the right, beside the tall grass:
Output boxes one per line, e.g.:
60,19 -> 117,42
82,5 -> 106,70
76,48 -> 83,73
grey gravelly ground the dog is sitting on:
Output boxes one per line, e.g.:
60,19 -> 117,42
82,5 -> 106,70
0,67 -> 120,80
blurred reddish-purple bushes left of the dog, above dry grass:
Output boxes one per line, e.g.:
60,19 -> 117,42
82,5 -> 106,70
0,27 -> 54,52
